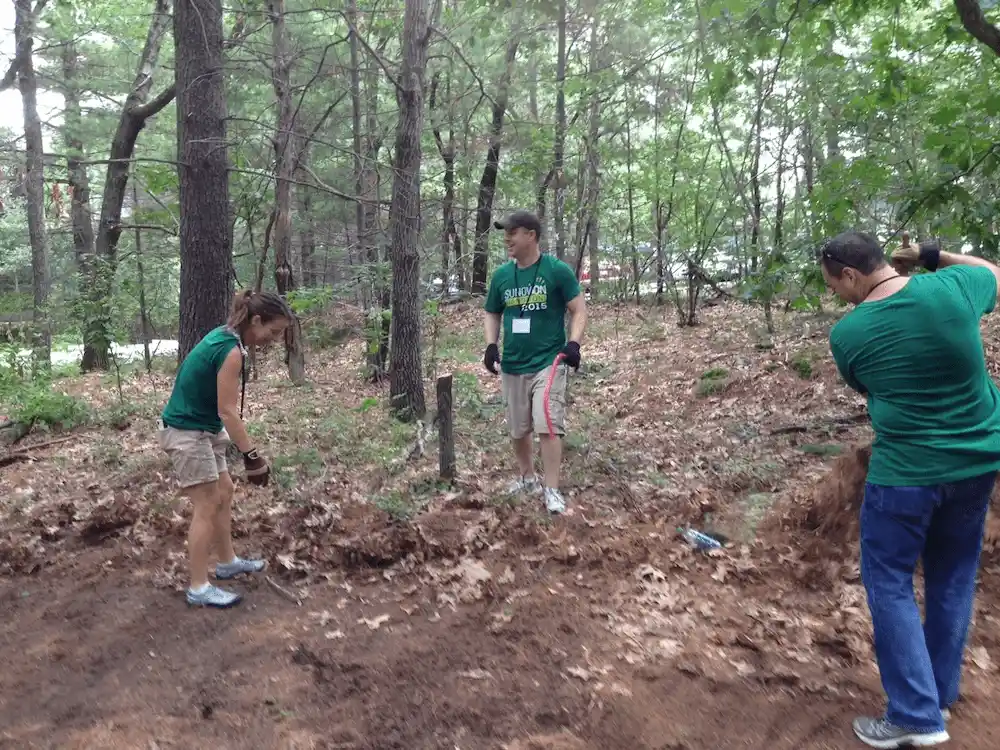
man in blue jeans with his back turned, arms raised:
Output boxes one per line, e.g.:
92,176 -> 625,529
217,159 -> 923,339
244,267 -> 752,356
820,232 -> 1000,748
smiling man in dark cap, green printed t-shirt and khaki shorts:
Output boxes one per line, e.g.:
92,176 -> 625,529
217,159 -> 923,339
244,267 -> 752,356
483,211 -> 587,513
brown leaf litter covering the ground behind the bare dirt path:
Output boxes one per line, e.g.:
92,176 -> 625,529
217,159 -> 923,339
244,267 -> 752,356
9,303 -> 1000,750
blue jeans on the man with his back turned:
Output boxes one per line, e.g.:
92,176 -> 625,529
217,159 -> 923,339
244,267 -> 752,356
861,472 -> 997,732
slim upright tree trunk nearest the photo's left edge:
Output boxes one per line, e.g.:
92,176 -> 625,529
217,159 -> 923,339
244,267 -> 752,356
14,0 -> 52,373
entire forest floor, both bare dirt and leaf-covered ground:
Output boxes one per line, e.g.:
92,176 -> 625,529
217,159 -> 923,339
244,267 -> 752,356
0,303 -> 1000,750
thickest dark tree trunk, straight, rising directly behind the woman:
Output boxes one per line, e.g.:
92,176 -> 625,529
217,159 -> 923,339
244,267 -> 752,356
174,0 -> 233,360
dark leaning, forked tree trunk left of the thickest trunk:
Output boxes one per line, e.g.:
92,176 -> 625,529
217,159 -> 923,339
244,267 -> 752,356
81,0 -> 176,372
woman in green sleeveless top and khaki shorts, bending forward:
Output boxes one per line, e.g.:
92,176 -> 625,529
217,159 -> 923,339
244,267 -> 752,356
159,291 -> 297,607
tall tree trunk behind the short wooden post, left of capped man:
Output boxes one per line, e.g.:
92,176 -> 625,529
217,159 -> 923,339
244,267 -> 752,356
389,0 -> 430,421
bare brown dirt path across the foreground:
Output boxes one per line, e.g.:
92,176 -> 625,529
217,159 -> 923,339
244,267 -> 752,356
0,512 -> 1000,750
